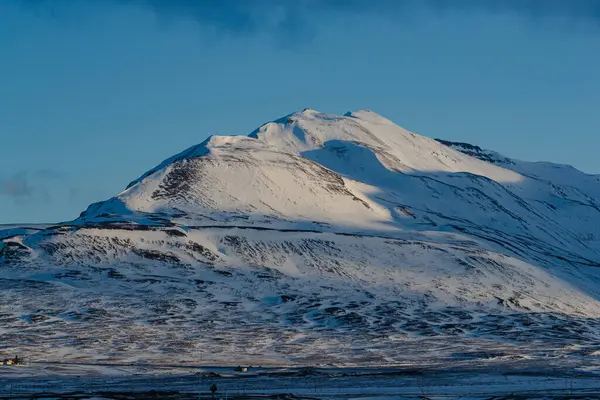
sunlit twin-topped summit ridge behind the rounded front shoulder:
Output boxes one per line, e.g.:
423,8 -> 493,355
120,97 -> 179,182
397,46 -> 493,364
128,108 -> 521,199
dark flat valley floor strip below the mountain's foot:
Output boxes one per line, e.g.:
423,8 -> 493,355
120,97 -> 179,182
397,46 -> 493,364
0,363 -> 600,400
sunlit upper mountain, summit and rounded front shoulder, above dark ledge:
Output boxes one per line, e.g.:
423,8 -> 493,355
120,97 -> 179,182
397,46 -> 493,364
84,109 -> 540,229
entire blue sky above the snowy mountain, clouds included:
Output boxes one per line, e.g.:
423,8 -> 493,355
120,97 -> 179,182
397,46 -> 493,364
0,0 -> 600,223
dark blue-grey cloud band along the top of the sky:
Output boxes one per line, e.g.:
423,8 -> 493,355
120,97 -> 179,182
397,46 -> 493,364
17,0 -> 600,38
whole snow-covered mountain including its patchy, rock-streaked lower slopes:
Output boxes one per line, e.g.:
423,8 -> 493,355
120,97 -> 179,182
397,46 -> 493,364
0,109 -> 600,365
